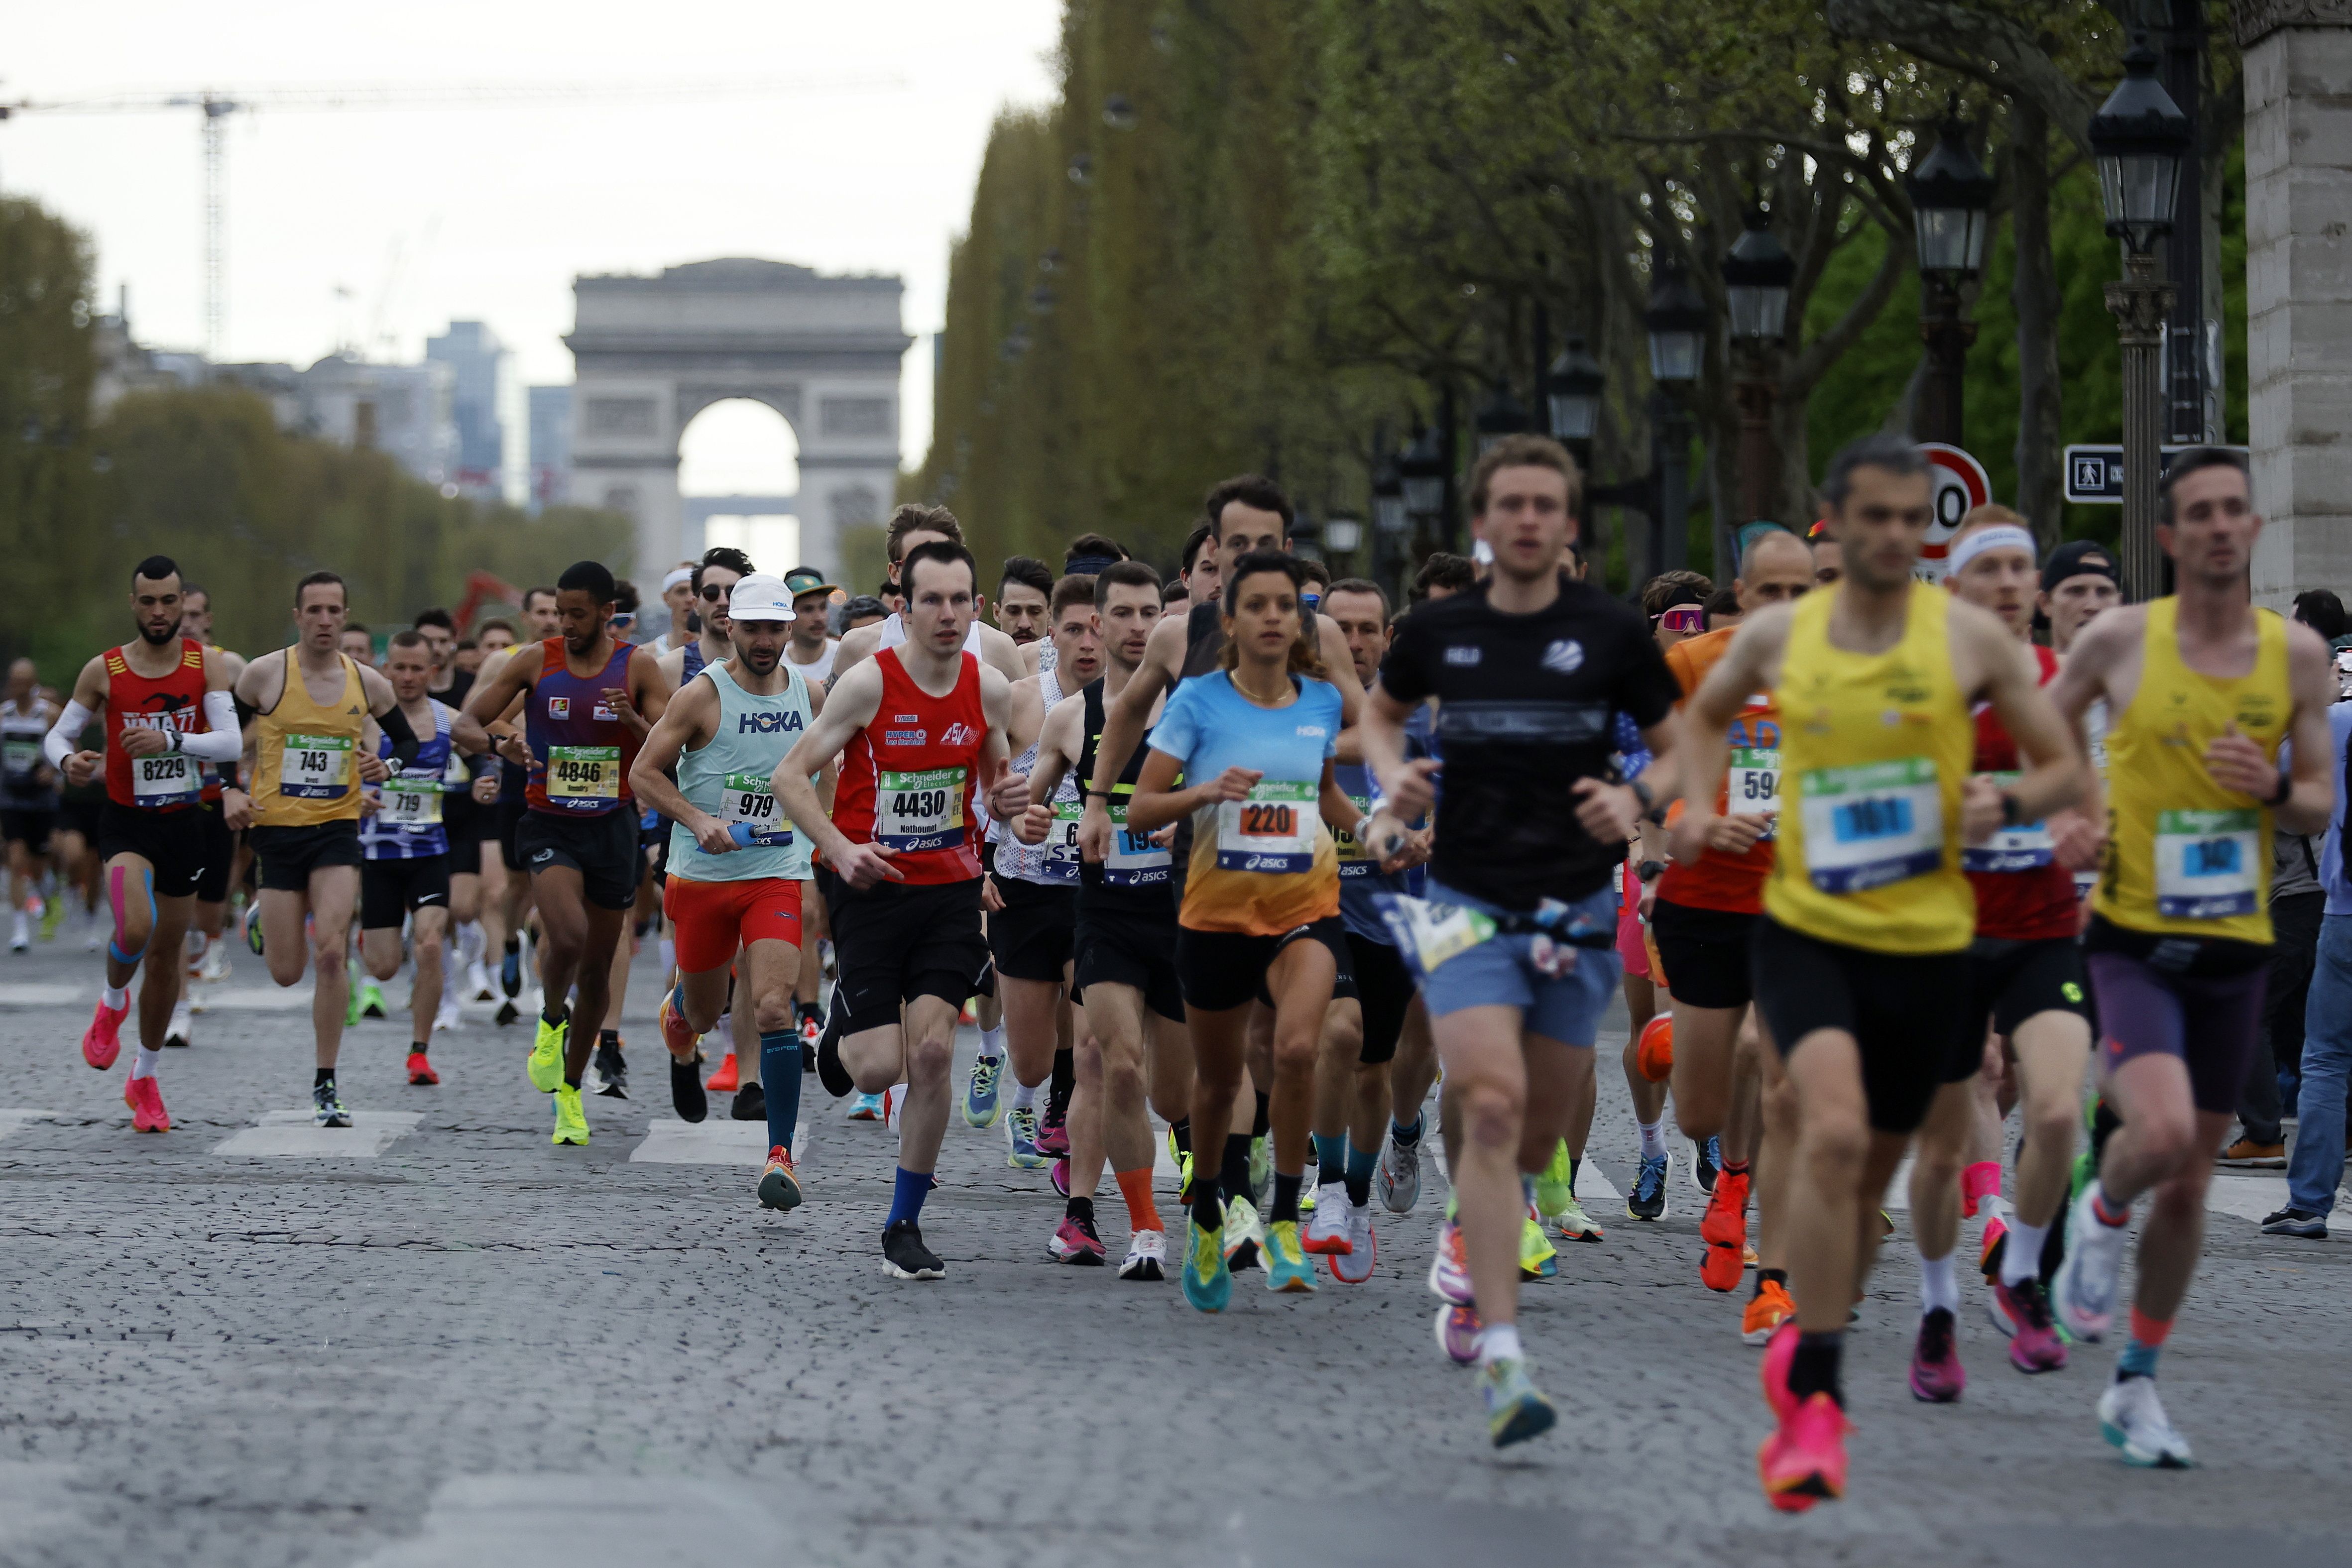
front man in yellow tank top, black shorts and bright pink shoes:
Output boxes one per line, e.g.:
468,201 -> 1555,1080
1674,435 -> 2082,1512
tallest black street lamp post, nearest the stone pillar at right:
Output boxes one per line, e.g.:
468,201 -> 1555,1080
2091,33 -> 2190,599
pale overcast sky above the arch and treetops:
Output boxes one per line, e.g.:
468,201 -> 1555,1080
0,0 -> 1061,491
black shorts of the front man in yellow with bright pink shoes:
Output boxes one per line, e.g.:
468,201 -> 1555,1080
1750,914 -> 1985,1133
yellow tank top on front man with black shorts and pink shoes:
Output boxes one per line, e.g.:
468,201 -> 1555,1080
1764,583 -> 1976,952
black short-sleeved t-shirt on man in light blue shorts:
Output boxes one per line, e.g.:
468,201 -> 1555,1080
1381,578 -> 1682,912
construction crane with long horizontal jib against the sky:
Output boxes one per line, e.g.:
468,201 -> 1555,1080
0,75 -> 906,357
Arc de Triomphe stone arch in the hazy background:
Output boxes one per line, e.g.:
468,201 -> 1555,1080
565,258 -> 913,583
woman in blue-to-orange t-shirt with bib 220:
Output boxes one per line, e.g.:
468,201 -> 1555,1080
1129,550 -> 1362,1312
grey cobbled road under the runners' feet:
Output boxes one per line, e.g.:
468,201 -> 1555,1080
0,931 -> 2352,1568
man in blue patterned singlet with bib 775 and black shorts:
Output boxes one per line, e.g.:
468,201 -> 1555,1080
360,630 -> 489,1084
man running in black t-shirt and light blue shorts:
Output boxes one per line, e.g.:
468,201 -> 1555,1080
1362,437 -> 1679,1446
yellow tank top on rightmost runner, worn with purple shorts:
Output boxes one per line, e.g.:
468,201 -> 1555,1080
2091,599 -> 2293,943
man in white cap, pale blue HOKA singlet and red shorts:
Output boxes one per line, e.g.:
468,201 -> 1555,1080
630,573 -> 832,1208
